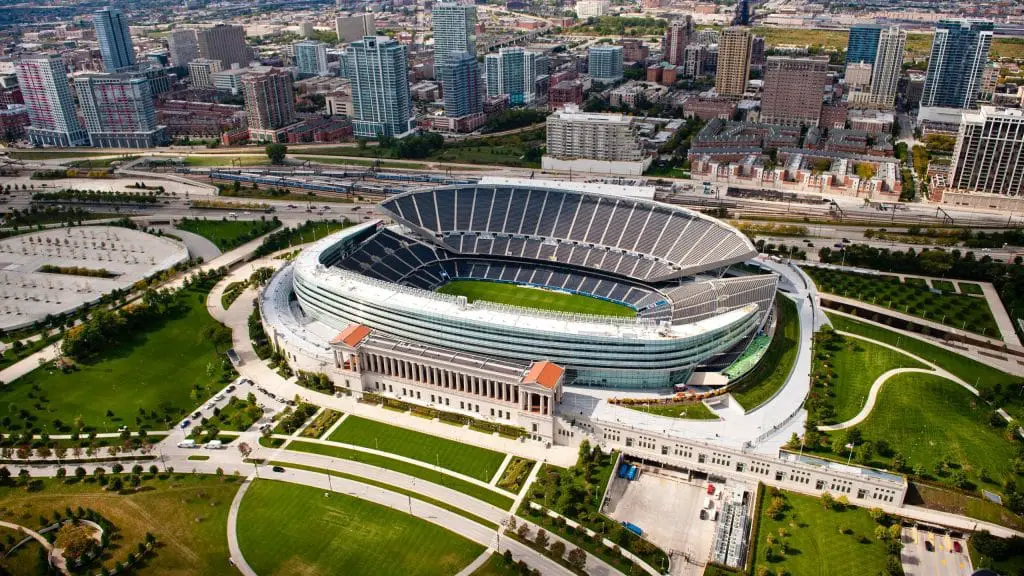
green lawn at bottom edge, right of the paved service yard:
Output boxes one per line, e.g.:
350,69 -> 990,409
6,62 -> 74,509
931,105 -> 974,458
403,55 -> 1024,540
751,489 -> 889,576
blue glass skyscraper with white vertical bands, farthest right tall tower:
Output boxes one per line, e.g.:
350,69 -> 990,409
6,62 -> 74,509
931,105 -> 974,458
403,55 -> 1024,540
921,19 -> 993,109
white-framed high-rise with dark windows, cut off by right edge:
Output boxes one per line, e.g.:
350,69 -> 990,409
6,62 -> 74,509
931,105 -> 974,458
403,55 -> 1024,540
949,106 -> 1024,197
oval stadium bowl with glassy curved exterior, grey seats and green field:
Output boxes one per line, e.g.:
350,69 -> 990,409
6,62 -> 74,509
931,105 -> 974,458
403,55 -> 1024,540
264,181 -> 778,388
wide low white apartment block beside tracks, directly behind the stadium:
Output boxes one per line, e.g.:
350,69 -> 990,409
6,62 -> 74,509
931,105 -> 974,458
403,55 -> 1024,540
542,105 -> 649,175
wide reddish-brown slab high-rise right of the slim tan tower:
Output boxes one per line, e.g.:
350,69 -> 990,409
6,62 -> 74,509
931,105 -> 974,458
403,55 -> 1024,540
761,56 -> 828,126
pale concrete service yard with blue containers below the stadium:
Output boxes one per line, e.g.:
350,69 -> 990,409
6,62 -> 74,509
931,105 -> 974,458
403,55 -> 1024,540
603,463 -> 722,575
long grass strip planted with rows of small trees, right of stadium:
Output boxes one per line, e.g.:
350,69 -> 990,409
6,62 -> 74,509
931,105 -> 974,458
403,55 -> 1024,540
804,266 -> 999,338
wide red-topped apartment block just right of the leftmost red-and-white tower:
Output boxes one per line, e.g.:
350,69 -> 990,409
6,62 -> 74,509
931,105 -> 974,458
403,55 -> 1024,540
75,74 -> 169,148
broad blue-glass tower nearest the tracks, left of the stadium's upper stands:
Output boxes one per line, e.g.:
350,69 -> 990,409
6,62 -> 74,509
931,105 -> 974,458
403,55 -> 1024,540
347,36 -> 416,138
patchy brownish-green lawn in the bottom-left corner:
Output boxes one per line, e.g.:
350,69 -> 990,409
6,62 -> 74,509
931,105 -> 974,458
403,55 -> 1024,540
0,465 -> 239,576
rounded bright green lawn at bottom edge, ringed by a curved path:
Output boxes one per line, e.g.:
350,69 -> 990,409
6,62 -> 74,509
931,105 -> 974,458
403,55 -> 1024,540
239,480 -> 484,576
